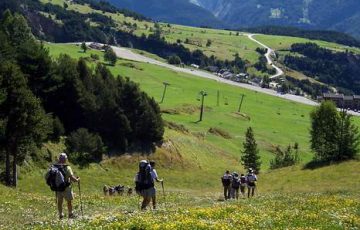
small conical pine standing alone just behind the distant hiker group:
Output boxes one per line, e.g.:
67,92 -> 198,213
241,127 -> 261,173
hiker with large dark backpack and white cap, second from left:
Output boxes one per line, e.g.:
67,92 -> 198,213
135,160 -> 155,210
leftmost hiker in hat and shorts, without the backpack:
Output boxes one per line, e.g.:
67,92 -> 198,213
54,153 -> 80,219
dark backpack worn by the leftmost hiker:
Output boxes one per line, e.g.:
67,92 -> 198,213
45,165 -> 70,192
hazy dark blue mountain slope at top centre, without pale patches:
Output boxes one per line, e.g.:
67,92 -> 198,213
108,0 -> 224,27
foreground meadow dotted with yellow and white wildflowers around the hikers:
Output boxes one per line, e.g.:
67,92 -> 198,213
0,162 -> 360,229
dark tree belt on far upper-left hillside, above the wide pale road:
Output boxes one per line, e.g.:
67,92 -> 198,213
0,0 -> 248,72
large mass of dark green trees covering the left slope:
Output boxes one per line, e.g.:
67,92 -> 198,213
0,11 -> 164,186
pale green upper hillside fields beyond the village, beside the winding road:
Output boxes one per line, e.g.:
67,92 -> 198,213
41,0 -> 360,66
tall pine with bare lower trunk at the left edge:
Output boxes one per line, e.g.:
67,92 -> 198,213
0,63 -> 51,186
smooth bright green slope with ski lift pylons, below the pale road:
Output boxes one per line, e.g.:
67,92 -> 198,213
45,42 -> 311,165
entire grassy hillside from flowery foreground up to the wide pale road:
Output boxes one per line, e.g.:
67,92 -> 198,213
0,39 -> 360,229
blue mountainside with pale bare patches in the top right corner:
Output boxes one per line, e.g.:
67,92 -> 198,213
191,0 -> 360,37
